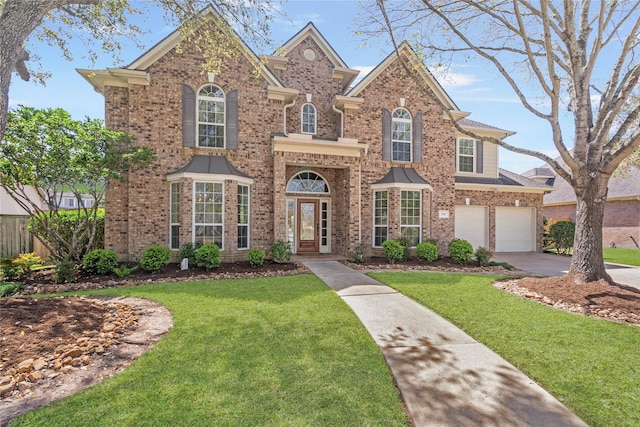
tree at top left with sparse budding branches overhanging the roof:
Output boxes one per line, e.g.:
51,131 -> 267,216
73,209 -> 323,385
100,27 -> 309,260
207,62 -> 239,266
0,0 -> 278,143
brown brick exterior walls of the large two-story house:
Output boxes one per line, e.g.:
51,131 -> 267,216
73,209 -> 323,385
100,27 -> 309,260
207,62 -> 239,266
104,25 -> 542,260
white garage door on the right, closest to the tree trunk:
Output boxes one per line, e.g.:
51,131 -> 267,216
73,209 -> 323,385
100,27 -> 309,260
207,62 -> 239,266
496,207 -> 536,252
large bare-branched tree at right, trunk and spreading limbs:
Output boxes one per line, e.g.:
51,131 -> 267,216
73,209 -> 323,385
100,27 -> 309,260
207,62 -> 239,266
360,0 -> 640,283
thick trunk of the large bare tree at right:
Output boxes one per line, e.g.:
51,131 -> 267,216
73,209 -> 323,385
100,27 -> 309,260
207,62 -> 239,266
568,176 -> 614,284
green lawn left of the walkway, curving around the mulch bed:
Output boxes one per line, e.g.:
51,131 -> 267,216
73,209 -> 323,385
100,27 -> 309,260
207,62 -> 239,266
12,275 -> 408,426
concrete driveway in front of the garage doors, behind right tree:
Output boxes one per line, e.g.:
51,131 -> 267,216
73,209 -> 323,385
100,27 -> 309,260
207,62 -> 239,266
493,252 -> 640,289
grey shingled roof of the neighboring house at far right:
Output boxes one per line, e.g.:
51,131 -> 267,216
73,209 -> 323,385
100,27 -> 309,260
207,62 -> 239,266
544,167 -> 640,205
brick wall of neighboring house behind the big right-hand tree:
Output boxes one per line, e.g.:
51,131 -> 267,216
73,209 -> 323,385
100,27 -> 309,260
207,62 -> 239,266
544,200 -> 640,248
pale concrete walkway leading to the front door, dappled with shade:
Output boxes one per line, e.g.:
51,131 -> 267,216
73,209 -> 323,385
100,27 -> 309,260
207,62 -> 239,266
302,260 -> 586,427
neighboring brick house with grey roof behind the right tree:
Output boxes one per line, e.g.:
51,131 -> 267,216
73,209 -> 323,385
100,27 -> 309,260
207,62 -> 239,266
524,167 -> 640,248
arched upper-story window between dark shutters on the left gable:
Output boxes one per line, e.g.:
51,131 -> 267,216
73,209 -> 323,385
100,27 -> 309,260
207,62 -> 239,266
198,85 -> 225,148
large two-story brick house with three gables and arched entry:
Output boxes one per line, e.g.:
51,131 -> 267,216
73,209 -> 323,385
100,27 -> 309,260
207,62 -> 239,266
78,9 -> 551,260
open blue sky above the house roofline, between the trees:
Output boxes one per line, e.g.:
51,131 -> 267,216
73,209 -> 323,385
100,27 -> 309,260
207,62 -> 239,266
9,0 -> 568,173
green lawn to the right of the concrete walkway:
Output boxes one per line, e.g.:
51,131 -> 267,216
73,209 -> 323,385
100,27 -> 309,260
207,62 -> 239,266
371,273 -> 640,426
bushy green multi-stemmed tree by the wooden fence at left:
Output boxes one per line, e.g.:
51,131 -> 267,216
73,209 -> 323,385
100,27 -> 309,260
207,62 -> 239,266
0,107 -> 153,263
